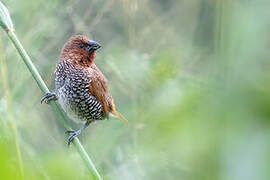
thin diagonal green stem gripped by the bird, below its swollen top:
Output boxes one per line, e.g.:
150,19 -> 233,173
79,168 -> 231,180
6,30 -> 102,180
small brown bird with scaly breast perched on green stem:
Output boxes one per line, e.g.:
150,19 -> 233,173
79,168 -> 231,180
41,35 -> 128,145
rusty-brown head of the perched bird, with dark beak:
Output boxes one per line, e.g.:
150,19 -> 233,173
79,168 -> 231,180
60,35 -> 101,67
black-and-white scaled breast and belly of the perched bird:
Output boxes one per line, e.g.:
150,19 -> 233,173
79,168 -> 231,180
55,61 -> 106,122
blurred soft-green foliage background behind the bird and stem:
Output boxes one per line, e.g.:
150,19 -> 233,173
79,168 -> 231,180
0,0 -> 270,180
